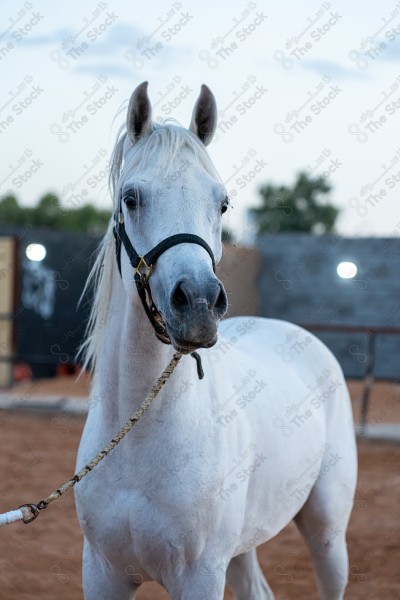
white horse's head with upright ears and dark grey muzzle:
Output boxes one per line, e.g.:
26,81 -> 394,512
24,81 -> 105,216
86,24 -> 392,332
115,82 -> 229,353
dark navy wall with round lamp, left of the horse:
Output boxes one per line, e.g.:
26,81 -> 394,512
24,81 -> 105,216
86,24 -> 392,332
0,226 -> 98,376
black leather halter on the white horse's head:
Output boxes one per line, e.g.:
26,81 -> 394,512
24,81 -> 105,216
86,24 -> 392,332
113,195 -> 215,379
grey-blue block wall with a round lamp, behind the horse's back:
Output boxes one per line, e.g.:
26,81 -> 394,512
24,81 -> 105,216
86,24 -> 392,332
259,234 -> 400,378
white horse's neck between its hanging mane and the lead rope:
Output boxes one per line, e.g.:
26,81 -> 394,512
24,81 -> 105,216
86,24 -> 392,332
94,269 -> 177,427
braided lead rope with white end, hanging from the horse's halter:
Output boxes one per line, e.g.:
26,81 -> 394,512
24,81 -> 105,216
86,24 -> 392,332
0,352 -> 182,527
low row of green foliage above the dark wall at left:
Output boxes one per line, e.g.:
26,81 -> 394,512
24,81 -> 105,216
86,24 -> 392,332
0,193 -> 111,233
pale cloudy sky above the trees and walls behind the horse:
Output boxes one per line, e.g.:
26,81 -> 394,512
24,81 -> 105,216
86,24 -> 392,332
0,0 -> 400,240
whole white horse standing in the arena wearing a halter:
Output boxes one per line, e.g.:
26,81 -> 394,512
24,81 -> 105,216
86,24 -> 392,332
75,83 -> 357,600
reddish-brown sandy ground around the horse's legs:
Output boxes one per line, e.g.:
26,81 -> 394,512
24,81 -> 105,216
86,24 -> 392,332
0,404 -> 400,600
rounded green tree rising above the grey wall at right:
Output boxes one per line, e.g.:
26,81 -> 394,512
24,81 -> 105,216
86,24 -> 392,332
251,173 -> 339,234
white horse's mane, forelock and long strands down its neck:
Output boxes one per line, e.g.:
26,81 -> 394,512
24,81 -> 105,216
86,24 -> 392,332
79,122 -> 220,370
